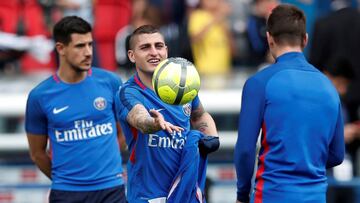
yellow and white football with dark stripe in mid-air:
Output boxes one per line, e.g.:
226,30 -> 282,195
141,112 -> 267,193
152,57 -> 200,105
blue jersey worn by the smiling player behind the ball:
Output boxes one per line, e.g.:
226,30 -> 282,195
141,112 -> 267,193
118,74 -> 200,203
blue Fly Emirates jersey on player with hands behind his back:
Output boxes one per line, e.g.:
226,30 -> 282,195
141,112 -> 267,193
25,68 -> 124,191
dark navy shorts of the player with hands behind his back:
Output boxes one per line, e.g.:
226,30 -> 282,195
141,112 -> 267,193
49,185 -> 126,203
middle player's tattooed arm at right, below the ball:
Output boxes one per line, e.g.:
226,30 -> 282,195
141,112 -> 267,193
191,103 -> 218,137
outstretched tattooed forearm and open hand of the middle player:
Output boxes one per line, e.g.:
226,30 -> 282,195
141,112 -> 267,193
126,104 -> 183,134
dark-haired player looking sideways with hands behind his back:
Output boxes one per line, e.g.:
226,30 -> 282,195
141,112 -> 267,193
25,16 -> 126,203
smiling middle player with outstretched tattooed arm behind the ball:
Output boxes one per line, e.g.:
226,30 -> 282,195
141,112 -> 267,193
118,25 -> 219,203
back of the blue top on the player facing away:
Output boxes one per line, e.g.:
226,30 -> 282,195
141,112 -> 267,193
256,53 -> 341,192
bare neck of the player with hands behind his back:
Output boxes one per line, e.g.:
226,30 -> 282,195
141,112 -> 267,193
58,65 -> 88,83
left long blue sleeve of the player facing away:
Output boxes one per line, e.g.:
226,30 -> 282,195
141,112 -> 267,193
234,78 -> 265,201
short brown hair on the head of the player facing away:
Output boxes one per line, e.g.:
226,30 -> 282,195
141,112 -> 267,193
267,4 -> 306,46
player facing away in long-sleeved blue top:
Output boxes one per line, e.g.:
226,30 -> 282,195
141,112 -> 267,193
234,4 -> 344,203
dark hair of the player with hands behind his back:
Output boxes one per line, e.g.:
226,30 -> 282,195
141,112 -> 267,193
53,16 -> 92,44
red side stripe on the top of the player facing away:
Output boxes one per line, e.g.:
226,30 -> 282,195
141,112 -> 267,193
254,123 -> 269,203
